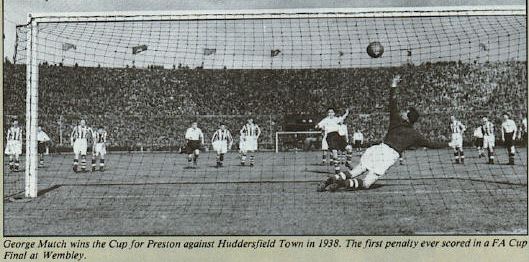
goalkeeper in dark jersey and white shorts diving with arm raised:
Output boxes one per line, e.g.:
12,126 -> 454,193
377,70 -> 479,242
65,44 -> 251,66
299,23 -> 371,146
318,75 -> 446,191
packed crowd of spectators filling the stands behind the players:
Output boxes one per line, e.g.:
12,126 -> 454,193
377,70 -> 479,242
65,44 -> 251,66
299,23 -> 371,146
4,61 -> 527,149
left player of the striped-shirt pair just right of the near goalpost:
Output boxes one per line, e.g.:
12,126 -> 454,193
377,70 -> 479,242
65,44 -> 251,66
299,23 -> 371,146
70,119 -> 92,172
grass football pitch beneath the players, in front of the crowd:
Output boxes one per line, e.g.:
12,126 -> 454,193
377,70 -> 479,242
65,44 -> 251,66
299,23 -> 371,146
4,148 -> 527,235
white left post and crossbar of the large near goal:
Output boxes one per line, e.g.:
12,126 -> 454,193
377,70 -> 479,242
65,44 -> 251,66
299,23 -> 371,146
24,5 -> 526,198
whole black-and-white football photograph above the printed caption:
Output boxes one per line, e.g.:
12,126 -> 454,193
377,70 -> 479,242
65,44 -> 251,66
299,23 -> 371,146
2,0 -> 528,237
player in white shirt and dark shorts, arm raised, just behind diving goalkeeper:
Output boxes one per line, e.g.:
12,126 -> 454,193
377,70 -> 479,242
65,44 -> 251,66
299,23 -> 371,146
316,108 -> 349,173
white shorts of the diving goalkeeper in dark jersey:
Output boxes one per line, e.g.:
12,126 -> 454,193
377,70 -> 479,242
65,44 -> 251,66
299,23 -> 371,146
360,143 -> 399,176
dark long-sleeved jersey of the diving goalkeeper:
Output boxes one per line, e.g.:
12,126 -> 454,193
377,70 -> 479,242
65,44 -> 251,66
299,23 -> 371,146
384,84 -> 444,154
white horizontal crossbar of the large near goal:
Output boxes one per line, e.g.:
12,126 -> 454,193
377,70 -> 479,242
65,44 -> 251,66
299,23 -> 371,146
29,5 -> 526,23
